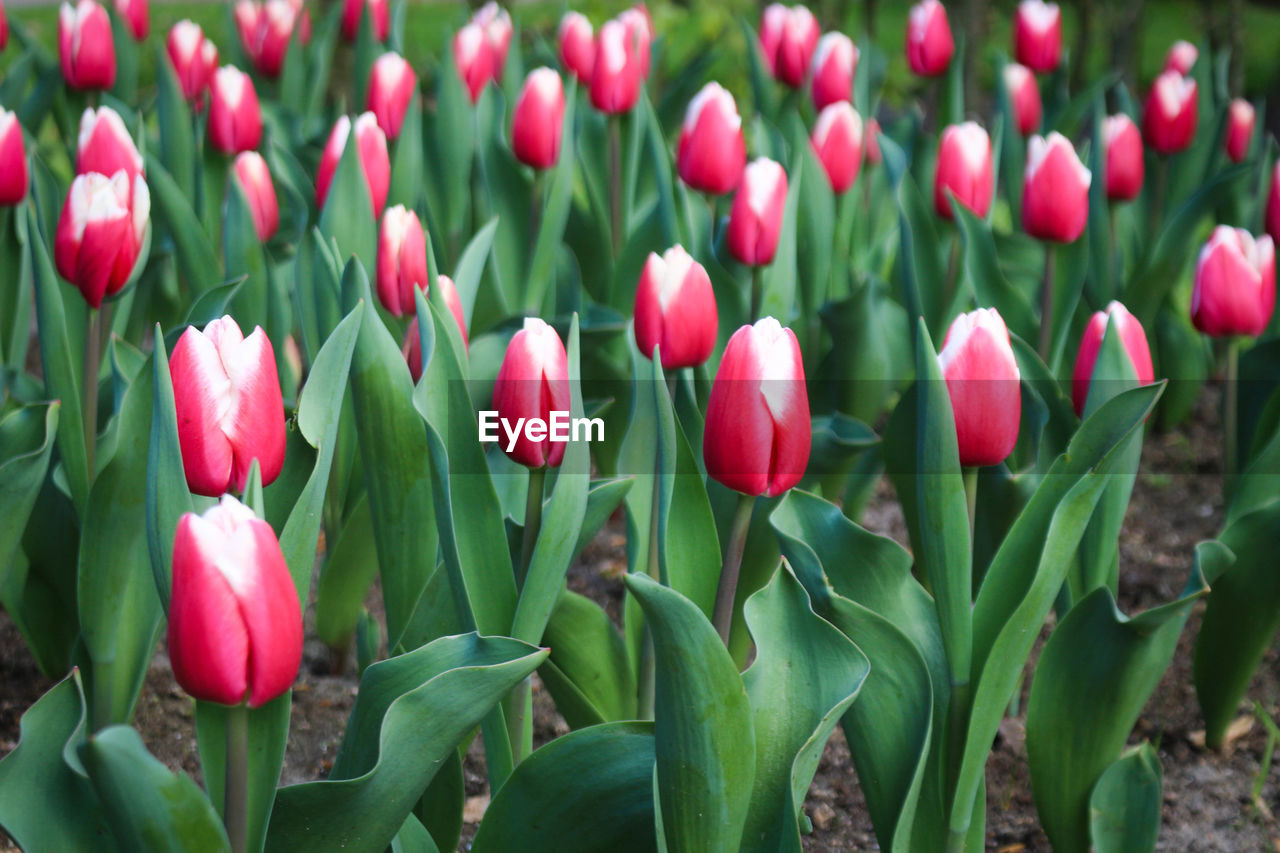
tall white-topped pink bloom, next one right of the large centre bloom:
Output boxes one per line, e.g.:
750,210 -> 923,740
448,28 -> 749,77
938,309 -> 1023,467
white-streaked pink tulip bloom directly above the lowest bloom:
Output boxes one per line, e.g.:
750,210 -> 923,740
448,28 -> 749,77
169,316 -> 284,497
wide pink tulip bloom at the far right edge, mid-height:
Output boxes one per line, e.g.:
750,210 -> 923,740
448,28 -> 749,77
1192,225 -> 1276,338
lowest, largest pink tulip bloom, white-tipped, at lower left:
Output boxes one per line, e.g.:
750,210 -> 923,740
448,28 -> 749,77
169,496 -> 302,708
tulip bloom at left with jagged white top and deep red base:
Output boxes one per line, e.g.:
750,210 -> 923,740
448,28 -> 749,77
54,170 -> 151,309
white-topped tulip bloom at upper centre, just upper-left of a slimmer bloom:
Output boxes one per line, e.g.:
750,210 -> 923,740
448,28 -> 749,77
676,83 -> 746,196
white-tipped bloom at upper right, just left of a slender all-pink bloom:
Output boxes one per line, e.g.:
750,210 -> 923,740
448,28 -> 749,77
1023,131 -> 1092,243
